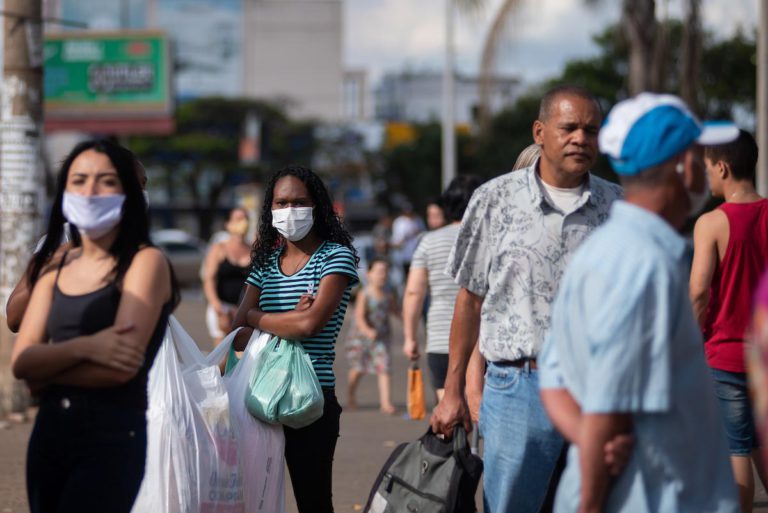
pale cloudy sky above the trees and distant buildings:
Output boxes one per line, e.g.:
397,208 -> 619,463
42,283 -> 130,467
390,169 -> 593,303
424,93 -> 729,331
344,0 -> 759,83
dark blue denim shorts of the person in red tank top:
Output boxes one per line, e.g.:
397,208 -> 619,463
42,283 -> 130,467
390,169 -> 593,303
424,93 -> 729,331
712,369 -> 760,456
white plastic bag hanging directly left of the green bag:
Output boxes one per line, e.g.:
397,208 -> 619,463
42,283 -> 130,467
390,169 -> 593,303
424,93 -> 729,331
224,330 -> 285,513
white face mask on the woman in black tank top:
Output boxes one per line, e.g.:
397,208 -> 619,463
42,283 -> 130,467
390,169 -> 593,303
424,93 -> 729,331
61,192 -> 125,240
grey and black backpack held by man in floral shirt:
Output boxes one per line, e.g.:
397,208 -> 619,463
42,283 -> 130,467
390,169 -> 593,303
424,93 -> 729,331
364,426 -> 483,513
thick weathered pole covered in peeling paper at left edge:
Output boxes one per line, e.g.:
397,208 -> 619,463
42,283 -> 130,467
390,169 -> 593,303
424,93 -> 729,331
0,0 -> 45,419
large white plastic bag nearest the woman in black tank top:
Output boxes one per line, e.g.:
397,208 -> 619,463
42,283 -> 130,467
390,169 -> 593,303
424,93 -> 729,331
133,316 -> 244,513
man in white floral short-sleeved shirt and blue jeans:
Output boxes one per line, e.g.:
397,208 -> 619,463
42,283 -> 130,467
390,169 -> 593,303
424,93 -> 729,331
431,86 -> 621,513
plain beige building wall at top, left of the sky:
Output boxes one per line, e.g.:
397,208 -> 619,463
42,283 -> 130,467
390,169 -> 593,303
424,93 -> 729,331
243,0 -> 343,121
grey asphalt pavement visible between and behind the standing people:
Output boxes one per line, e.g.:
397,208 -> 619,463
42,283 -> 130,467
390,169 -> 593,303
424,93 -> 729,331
0,291 -> 768,513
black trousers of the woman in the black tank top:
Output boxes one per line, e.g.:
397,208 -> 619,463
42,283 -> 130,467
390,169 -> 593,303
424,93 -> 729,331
27,397 -> 147,513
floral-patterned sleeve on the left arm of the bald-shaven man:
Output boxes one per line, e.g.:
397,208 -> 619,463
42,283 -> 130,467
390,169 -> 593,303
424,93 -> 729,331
445,188 -> 491,296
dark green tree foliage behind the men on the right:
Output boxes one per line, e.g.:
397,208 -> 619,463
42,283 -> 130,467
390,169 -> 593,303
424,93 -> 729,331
383,24 -> 756,207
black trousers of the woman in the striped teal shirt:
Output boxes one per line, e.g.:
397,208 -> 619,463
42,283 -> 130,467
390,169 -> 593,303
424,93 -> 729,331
283,388 -> 341,513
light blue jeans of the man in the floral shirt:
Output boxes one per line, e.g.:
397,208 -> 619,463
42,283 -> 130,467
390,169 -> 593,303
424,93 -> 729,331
480,362 -> 564,513
